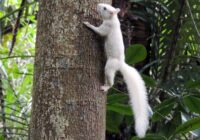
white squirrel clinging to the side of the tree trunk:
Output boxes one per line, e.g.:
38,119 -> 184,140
83,3 -> 149,138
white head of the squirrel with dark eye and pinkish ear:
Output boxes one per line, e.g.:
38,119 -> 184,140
97,3 -> 120,19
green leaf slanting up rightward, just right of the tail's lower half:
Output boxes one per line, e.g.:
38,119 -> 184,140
152,98 -> 176,122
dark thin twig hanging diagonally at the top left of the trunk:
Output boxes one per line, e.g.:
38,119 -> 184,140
8,0 -> 26,56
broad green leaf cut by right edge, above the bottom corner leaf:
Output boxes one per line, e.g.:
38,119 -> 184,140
183,96 -> 200,114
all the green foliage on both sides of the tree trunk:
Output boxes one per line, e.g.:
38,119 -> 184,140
0,0 -> 200,140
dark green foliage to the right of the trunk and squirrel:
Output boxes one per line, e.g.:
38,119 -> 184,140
107,0 -> 200,140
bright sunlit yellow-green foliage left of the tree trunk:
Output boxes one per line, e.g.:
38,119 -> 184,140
0,0 -> 37,139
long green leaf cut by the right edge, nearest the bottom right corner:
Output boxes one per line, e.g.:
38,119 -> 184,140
175,117 -> 200,134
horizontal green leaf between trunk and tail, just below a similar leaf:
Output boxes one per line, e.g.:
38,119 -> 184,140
107,103 -> 133,116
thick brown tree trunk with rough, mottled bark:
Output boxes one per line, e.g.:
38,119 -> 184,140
29,0 -> 111,140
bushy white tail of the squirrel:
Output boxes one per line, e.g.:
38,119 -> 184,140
120,63 -> 149,138
